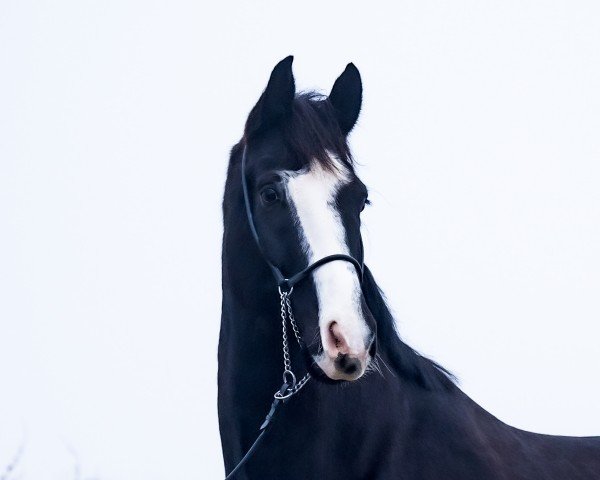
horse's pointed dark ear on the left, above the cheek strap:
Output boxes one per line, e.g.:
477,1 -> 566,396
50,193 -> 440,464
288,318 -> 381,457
245,55 -> 296,137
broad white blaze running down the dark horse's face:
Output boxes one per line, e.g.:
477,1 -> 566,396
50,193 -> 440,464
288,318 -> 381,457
287,157 -> 369,366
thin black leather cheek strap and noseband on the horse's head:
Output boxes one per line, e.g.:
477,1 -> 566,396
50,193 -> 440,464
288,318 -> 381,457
241,145 -> 364,290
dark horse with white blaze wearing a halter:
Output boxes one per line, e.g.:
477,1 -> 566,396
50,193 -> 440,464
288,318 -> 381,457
218,56 -> 600,480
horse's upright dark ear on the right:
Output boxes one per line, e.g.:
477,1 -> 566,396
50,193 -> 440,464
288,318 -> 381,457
329,63 -> 362,135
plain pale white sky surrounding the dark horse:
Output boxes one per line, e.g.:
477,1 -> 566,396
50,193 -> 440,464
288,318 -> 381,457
0,0 -> 600,480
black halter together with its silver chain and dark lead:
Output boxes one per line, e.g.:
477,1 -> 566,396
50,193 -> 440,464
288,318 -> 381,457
225,145 -> 364,480
